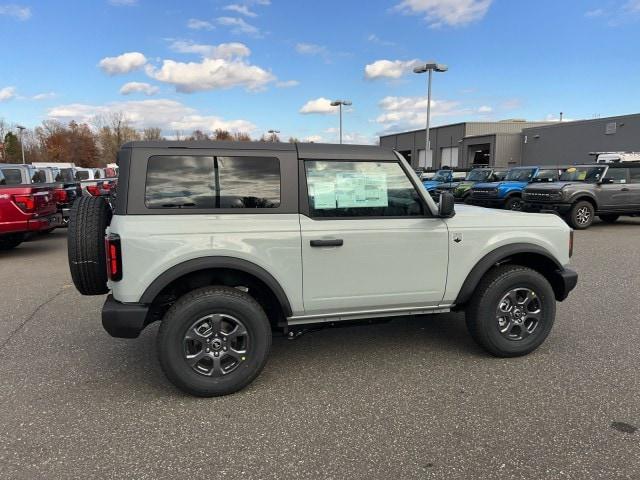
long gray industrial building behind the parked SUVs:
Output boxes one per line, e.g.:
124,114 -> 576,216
380,114 -> 640,169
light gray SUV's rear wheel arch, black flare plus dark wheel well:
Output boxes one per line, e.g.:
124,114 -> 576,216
140,257 -> 292,321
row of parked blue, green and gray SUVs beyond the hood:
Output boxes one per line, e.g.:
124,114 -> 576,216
423,160 -> 640,230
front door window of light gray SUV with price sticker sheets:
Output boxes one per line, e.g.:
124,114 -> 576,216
305,161 -> 424,217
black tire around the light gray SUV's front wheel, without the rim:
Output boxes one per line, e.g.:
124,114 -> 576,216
465,265 -> 556,357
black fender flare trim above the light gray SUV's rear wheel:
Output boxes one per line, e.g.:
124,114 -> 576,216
140,257 -> 293,317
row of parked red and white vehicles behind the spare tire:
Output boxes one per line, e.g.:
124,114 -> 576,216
0,163 -> 118,250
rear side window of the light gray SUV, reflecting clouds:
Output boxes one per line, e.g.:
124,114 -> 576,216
145,156 -> 280,209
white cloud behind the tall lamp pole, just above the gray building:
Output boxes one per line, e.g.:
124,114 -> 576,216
376,96 -> 474,130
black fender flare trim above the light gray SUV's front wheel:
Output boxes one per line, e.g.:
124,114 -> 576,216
455,243 -> 564,305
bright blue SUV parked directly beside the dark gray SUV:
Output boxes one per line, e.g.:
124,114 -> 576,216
469,167 -> 561,210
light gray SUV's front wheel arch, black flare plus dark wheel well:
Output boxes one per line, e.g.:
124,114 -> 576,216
455,243 -> 564,306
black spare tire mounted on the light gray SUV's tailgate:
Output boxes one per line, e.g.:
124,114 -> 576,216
67,196 -> 112,295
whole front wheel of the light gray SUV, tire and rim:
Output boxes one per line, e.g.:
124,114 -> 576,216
466,265 -> 556,357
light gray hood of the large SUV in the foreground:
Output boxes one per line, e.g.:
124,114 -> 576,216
447,204 -> 569,229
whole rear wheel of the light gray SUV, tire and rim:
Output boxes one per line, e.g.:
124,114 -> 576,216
158,287 -> 272,397
